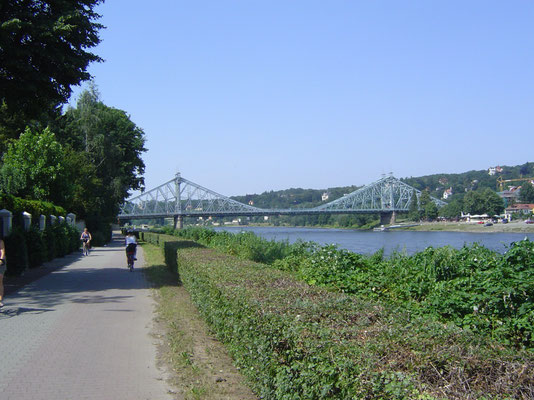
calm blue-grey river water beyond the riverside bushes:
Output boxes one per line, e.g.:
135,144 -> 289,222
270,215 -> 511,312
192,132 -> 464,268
217,227 -> 534,255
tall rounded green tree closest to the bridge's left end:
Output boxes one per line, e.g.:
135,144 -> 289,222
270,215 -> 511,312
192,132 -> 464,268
56,86 -> 146,222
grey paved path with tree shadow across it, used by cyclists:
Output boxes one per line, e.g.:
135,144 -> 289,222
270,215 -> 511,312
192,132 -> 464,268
0,239 -> 173,400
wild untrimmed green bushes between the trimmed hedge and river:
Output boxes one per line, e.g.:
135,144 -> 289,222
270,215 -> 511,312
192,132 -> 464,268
159,228 -> 534,349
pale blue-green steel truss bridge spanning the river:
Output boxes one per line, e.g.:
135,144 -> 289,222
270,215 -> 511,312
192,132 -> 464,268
119,173 -> 446,227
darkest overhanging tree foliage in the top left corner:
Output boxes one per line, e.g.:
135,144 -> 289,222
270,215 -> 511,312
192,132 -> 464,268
0,0 -> 103,144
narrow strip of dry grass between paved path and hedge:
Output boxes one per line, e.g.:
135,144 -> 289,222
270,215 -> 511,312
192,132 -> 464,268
142,243 -> 256,400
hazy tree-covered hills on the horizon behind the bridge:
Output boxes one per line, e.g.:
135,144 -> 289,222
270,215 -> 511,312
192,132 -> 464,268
232,162 -> 534,208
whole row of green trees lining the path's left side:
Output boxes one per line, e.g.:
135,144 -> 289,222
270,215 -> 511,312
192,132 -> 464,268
0,0 -> 146,239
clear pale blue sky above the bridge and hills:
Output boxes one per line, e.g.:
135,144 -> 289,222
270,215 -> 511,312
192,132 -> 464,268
71,0 -> 534,196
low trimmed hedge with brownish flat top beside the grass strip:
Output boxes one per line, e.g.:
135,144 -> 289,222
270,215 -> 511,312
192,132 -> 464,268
147,233 -> 534,399
